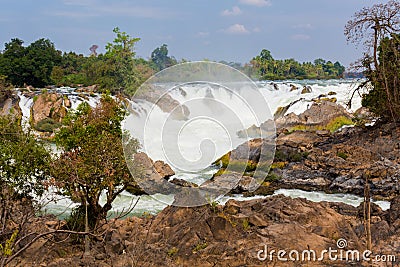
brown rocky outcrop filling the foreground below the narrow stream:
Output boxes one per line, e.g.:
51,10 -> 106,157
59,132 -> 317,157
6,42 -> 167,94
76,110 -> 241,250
13,195 -> 400,267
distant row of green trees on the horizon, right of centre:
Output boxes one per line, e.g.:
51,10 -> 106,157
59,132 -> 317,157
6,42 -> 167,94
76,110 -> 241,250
250,49 -> 345,80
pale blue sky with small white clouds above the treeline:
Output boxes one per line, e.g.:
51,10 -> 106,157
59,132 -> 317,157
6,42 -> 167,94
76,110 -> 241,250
0,0 -> 385,66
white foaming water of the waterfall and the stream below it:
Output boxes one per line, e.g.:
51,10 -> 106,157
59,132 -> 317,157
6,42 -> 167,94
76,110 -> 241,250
19,80 -> 390,217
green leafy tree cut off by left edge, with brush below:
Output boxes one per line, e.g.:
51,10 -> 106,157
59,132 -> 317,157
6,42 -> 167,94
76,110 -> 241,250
0,116 -> 51,266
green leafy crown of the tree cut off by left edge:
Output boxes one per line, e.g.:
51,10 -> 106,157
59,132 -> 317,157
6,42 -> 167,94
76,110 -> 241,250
0,116 -> 51,196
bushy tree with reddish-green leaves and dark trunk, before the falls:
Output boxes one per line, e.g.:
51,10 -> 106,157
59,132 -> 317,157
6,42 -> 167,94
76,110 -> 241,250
51,96 -> 139,228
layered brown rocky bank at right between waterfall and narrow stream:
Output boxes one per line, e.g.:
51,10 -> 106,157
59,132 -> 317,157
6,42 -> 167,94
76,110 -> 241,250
213,102 -> 400,200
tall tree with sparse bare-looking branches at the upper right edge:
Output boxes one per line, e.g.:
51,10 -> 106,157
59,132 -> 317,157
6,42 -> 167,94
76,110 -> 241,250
344,0 -> 400,121
